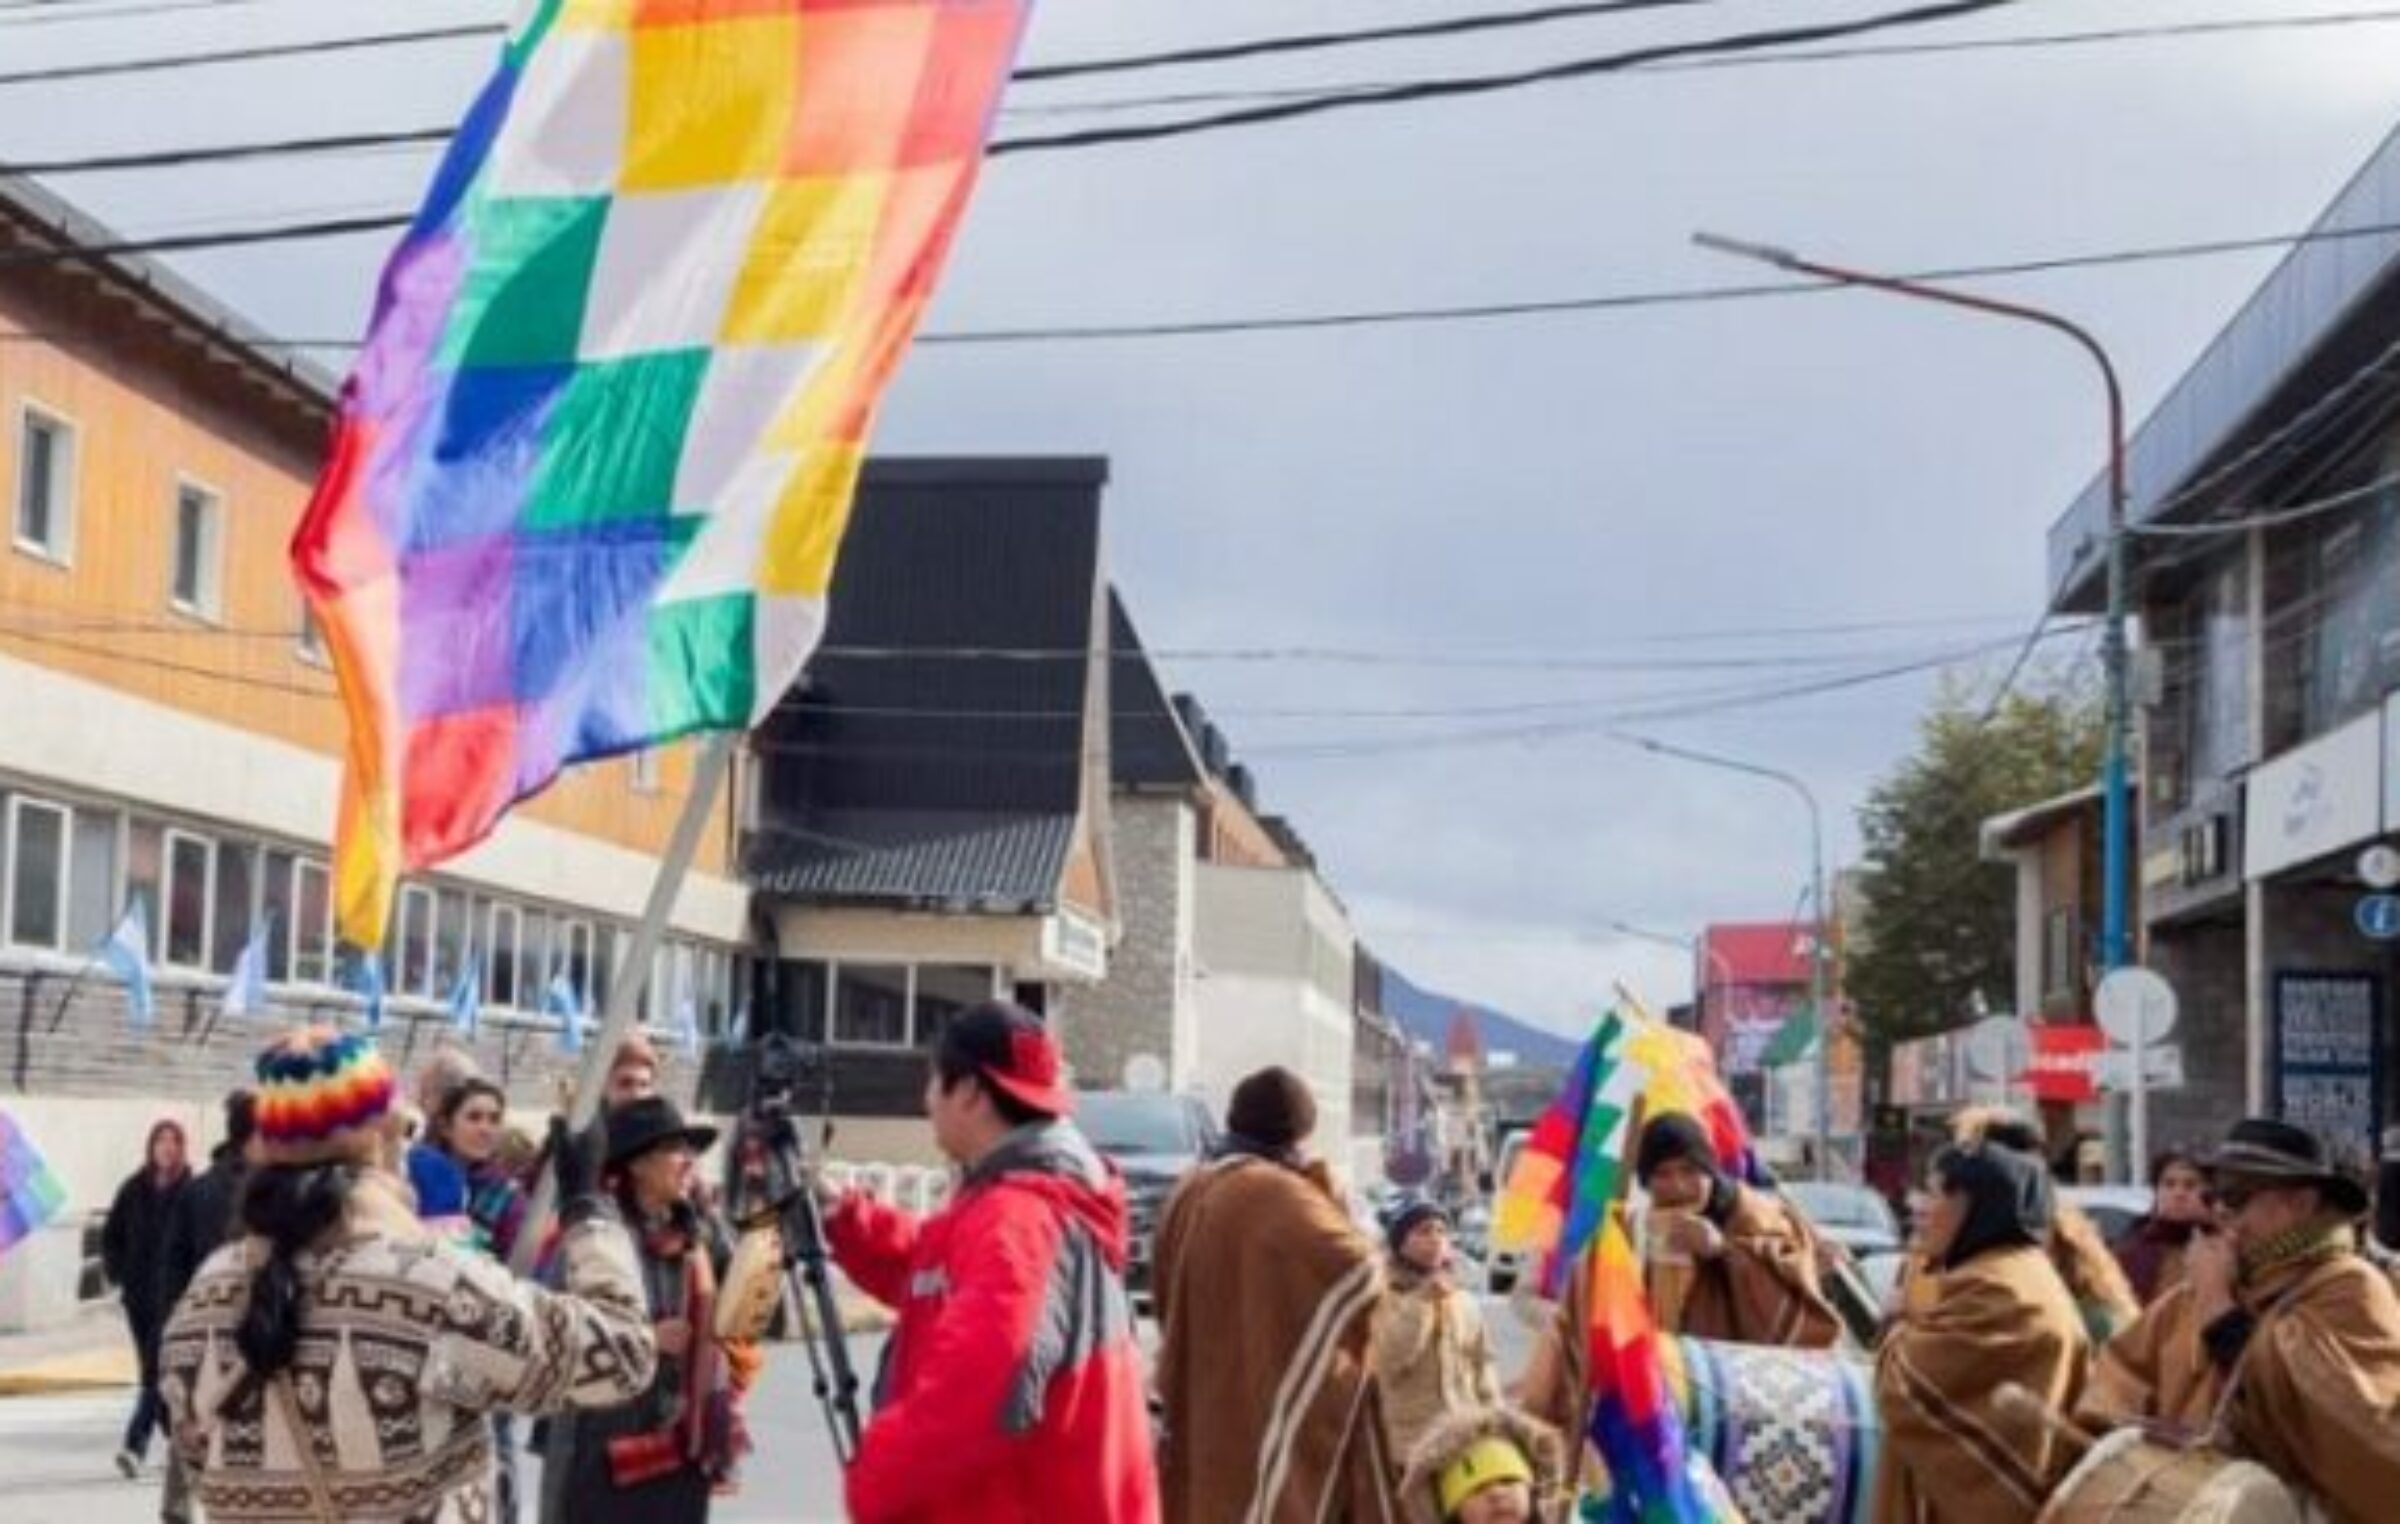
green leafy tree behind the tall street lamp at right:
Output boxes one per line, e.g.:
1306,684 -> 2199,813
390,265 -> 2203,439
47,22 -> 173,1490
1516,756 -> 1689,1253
1843,677 -> 2102,1068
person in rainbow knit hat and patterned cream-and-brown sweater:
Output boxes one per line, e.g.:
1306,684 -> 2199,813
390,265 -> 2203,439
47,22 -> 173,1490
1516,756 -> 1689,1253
161,1027 -> 658,1524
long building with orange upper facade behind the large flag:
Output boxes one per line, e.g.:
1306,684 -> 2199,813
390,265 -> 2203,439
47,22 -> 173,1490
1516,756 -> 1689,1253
0,180 -> 749,1325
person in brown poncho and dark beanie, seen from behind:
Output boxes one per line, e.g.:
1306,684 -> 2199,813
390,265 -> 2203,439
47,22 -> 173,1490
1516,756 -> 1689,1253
1152,1068 -> 1399,1524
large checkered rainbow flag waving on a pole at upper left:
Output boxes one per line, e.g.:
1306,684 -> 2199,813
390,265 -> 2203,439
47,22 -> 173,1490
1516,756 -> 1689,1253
293,0 -> 1032,950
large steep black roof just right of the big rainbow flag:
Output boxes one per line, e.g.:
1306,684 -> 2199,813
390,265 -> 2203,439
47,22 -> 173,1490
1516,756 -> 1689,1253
744,458 -> 1109,910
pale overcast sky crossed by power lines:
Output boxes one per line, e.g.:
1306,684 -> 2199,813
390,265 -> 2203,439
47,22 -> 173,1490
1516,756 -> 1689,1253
0,0 -> 2400,1027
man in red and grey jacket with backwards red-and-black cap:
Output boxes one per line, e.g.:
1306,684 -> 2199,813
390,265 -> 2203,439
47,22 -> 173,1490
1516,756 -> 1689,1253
826,1001 -> 1159,1524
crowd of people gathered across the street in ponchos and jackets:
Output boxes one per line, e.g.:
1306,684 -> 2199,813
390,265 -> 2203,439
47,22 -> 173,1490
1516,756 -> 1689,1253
106,1003 -> 2400,1524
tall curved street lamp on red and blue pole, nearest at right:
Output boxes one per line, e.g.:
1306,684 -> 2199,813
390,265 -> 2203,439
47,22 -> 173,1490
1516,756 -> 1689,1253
1692,233 -> 2134,972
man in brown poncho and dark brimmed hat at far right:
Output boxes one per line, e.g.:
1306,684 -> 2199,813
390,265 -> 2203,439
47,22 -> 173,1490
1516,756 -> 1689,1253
2078,1118 -> 2400,1524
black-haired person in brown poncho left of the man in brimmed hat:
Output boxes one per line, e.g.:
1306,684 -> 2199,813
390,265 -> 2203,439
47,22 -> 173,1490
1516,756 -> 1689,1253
1874,1142 -> 2088,1524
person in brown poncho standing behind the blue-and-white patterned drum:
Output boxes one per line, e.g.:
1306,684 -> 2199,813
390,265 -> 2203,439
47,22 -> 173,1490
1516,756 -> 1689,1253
1517,1114 -> 1841,1435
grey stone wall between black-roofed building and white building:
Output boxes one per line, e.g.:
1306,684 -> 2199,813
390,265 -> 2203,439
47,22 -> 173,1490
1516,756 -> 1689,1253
1058,792 -> 1198,1090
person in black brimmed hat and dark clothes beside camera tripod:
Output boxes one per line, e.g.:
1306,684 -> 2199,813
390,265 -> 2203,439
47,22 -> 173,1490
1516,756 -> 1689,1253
542,1097 -> 756,1524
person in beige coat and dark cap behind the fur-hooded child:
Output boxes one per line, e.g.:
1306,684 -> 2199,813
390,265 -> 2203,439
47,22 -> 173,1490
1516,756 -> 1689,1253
1375,1198 -> 1500,1457
